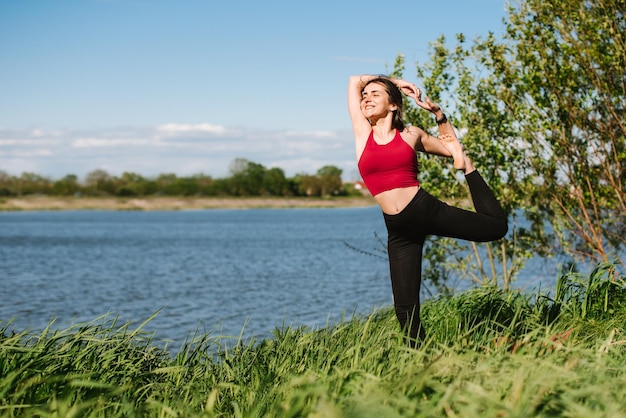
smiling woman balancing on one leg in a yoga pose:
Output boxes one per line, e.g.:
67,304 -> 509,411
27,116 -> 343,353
348,75 -> 508,347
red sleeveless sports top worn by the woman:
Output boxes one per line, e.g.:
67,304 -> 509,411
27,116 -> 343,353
358,129 -> 419,196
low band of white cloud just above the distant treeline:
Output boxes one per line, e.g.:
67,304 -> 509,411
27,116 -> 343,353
0,123 -> 355,179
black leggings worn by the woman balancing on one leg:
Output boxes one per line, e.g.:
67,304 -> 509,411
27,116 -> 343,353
383,171 -> 508,346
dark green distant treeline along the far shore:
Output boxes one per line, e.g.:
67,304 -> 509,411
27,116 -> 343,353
0,158 -> 359,197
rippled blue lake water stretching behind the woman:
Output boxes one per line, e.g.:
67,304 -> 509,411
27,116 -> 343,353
0,206 -> 556,347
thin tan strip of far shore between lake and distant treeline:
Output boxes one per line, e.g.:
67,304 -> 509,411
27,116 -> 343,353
0,196 -> 376,212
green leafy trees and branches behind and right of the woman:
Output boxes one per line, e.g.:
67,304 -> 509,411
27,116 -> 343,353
393,0 -> 626,289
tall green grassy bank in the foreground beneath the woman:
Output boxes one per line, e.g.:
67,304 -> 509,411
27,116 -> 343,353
0,266 -> 626,417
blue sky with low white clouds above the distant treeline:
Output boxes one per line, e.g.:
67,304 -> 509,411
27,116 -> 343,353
0,0 -> 505,180
